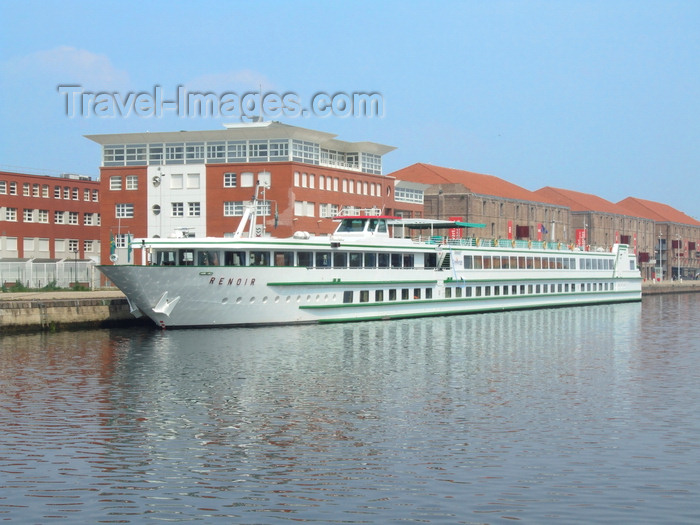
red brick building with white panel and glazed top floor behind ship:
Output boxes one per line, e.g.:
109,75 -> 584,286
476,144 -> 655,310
87,122 -> 423,264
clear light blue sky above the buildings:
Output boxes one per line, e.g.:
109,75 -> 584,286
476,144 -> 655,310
0,0 -> 700,219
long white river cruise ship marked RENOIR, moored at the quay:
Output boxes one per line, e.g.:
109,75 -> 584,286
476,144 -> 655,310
100,205 -> 641,328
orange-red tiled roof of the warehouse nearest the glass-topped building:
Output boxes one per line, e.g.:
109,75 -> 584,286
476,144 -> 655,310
391,163 -> 541,202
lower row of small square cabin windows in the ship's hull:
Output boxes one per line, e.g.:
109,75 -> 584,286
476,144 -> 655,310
343,282 -> 615,304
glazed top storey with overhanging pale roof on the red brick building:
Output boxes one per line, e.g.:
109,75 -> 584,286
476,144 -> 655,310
86,122 -> 395,175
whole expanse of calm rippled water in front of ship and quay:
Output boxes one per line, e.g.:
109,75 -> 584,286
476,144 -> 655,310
0,294 -> 700,524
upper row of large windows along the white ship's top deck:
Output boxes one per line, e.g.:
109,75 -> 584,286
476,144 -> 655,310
153,250 -> 613,270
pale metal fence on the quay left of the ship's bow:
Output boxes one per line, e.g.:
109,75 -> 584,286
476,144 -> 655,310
0,259 -> 100,289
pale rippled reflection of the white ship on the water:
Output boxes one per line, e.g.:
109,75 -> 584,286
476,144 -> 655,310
110,304 -> 641,460
